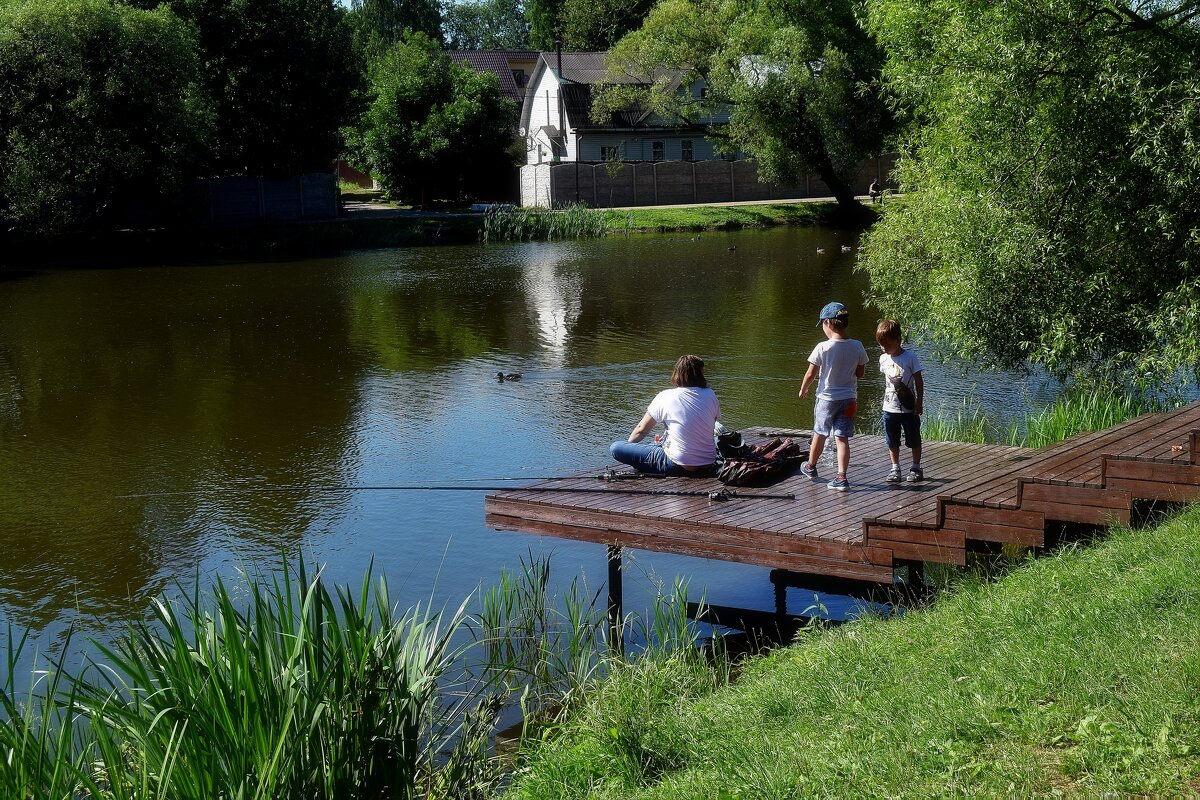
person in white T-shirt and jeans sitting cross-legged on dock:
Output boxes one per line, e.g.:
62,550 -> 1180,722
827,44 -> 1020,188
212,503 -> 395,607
608,355 -> 721,477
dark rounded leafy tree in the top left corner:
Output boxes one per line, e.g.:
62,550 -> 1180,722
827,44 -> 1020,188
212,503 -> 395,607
0,0 -> 212,231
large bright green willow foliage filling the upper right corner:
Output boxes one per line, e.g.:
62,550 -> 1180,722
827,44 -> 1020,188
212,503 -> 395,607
863,0 -> 1200,384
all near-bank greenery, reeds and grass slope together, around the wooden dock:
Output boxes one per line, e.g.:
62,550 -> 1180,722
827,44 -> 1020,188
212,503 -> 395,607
0,395 -> 1200,800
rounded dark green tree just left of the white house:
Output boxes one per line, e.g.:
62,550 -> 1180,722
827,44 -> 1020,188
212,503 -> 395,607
350,34 -> 517,199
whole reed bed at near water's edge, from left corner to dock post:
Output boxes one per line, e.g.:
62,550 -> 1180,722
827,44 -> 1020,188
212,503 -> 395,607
0,557 -> 696,800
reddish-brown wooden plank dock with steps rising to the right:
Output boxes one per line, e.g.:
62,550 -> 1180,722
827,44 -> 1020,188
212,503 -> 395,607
485,403 -> 1200,583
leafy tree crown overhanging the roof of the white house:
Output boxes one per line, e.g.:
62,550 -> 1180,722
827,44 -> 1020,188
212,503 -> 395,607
599,0 -> 892,206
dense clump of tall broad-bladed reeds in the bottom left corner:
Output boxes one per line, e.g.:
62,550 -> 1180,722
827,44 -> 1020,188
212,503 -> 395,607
0,566 -> 463,800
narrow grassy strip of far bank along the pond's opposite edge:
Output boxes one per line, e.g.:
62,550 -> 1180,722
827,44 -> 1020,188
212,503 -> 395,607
0,201 -> 864,267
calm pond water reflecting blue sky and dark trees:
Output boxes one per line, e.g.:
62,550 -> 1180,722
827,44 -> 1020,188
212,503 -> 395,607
0,228 -> 1054,646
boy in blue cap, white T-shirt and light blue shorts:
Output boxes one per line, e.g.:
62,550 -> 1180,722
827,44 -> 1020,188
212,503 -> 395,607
800,302 -> 866,492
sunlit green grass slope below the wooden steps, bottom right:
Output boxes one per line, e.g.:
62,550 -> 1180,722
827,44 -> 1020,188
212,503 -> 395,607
509,509 -> 1200,800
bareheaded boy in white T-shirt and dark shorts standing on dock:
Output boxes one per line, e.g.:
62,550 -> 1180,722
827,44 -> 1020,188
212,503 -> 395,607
875,319 -> 925,483
